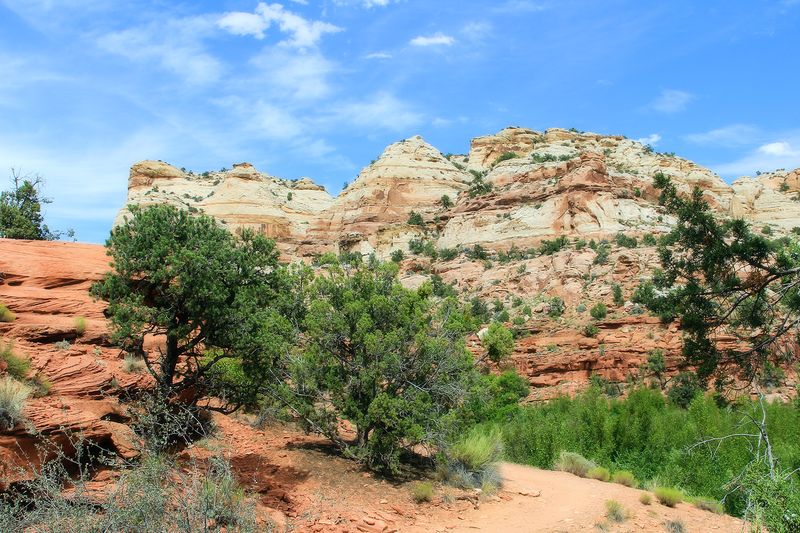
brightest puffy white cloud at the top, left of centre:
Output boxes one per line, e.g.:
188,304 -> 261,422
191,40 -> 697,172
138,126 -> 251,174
217,2 -> 342,49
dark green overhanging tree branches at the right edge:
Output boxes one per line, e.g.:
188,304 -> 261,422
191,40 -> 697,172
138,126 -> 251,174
636,173 -> 800,384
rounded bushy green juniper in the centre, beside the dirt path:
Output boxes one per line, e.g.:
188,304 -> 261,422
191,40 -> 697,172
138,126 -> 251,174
287,263 -> 478,473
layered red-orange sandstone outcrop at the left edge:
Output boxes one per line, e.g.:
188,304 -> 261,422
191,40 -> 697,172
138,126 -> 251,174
0,239 -> 142,490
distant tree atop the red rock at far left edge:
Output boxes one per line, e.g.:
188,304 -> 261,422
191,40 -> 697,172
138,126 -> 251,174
0,169 -> 73,241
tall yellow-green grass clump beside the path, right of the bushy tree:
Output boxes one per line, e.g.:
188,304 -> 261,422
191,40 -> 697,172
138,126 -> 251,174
443,426 -> 503,492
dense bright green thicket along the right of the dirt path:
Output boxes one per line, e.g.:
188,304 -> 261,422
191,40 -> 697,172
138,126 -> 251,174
502,387 -> 800,515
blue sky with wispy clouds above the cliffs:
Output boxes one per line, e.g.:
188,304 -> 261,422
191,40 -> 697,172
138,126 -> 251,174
0,0 -> 800,242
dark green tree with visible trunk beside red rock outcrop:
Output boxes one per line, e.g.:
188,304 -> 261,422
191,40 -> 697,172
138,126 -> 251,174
92,205 -> 293,410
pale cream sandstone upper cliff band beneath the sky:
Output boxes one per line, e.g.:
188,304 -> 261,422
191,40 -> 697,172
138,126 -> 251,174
116,124 -> 800,259
